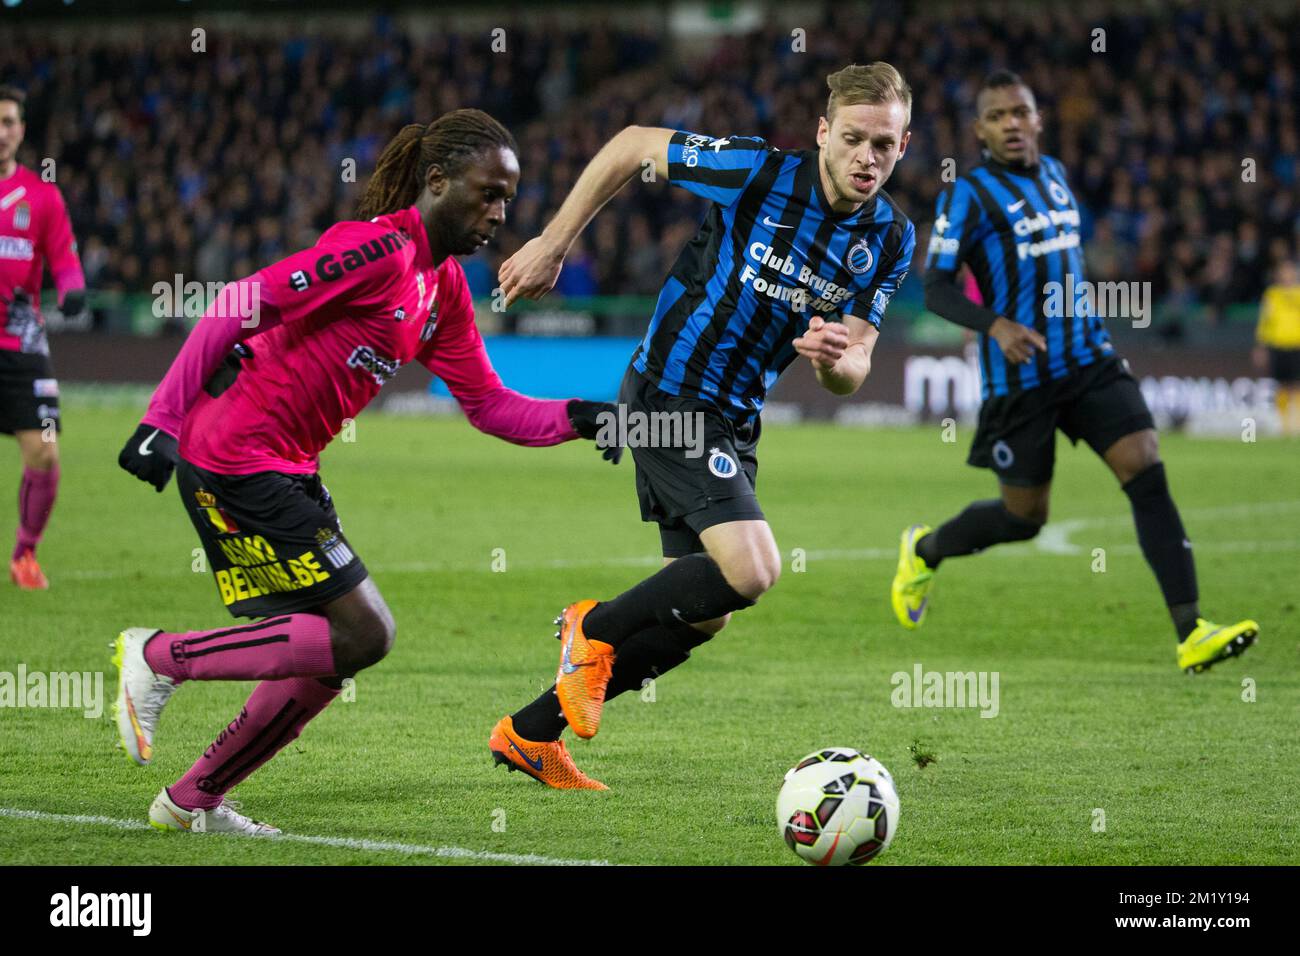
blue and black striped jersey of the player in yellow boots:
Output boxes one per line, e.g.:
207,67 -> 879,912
926,156 -> 1113,399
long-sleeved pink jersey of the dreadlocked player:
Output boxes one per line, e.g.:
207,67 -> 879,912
144,207 -> 577,475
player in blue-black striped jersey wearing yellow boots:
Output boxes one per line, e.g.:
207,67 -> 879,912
892,72 -> 1258,672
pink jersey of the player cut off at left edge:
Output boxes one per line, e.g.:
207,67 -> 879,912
0,165 -> 86,351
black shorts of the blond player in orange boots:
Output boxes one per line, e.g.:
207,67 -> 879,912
619,365 -> 763,558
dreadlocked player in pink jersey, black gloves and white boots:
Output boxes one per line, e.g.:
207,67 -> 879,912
114,109 -> 612,835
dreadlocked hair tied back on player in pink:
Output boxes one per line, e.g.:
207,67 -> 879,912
356,109 -> 519,220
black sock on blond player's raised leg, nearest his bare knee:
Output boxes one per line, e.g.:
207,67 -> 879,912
582,554 -> 754,648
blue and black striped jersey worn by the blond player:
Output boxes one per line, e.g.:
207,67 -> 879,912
632,131 -> 917,421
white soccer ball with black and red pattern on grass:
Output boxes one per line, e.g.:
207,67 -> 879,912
776,747 -> 898,866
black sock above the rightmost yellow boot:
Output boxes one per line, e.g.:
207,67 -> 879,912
1125,462 -> 1199,640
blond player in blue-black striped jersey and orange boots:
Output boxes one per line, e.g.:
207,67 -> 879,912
490,62 -> 915,788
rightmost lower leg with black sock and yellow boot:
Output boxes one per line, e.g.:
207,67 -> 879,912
1102,428 -> 1260,672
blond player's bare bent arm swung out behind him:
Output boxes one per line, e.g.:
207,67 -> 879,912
498,126 -> 673,307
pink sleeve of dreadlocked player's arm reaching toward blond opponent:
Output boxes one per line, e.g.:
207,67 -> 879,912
419,264 -> 577,447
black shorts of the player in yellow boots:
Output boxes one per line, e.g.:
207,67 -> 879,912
966,355 -> 1156,488
